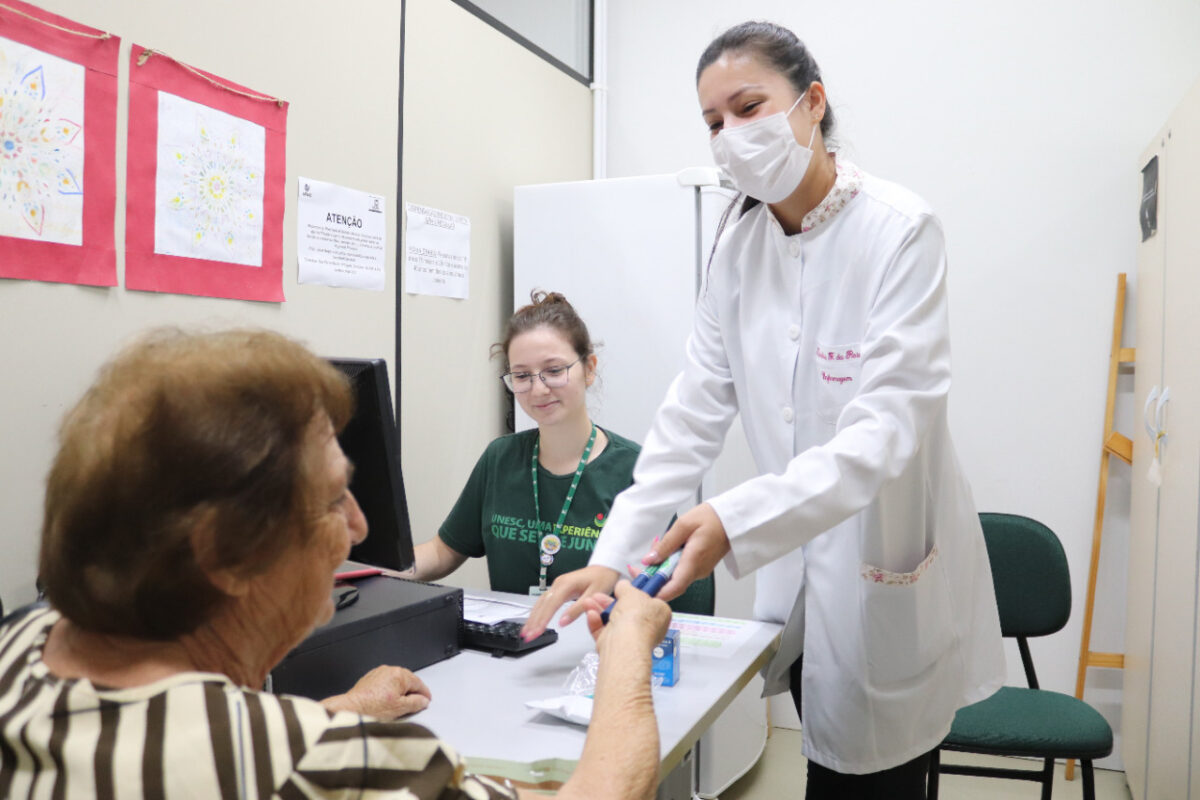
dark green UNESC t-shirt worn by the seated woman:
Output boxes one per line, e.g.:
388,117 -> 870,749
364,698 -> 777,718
438,428 -> 641,595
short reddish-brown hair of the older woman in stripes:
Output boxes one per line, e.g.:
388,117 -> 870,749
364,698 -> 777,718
40,329 -> 354,639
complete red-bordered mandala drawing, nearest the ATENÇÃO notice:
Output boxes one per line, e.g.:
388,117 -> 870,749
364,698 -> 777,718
125,44 -> 288,301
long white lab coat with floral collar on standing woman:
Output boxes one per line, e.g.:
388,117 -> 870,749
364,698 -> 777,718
592,169 -> 1004,774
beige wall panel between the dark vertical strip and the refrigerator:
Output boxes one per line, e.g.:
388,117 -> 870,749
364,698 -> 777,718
401,0 -> 592,587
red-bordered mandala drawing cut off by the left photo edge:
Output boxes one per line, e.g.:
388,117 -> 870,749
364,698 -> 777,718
0,0 -> 120,287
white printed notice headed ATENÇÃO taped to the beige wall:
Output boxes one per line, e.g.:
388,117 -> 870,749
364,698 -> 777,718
296,178 -> 388,291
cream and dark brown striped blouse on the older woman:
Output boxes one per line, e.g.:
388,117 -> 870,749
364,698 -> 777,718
0,608 -> 515,800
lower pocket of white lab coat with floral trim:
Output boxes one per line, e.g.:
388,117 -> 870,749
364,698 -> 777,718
862,546 -> 954,686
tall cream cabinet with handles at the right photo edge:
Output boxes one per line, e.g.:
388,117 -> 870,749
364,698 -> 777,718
1122,76 -> 1200,800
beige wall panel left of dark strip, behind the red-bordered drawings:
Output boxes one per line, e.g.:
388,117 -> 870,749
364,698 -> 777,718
0,0 -> 401,606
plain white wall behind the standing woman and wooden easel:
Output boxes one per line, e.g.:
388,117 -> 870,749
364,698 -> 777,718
608,0 -> 1200,765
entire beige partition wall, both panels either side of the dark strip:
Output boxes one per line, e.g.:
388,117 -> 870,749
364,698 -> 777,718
0,0 -> 592,606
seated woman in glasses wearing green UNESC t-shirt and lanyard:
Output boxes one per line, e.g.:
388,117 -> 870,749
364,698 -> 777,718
414,293 -> 713,613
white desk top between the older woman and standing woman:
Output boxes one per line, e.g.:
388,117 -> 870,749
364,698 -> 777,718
412,591 -> 781,789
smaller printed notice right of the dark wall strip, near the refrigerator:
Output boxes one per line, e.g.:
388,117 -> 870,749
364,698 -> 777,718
404,203 -> 470,300
